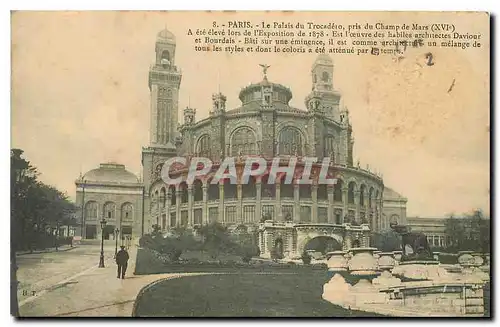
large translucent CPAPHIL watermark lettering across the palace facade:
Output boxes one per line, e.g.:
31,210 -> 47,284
161,156 -> 337,185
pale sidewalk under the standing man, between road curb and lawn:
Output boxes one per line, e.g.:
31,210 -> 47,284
19,247 -> 182,317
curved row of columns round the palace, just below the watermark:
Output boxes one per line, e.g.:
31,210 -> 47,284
151,179 -> 383,230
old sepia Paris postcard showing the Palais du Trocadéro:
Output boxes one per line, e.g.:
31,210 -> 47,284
10,11 -> 491,318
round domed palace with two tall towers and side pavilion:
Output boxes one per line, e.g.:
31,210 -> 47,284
76,29 -> 406,256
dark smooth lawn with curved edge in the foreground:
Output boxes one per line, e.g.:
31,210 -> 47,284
134,271 -> 382,317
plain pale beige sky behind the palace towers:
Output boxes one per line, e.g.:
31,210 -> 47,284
11,11 -> 490,217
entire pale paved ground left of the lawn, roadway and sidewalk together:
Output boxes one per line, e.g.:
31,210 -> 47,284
18,245 -> 178,317
